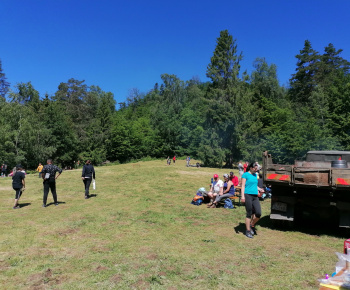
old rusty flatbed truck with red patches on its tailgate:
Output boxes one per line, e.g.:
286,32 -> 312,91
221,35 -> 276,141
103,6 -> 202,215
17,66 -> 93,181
262,151 -> 350,228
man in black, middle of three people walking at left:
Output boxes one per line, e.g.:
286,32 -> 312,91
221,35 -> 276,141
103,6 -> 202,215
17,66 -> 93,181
41,159 -> 62,207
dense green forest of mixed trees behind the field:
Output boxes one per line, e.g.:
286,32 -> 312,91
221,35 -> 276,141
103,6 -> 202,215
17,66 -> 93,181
0,30 -> 350,168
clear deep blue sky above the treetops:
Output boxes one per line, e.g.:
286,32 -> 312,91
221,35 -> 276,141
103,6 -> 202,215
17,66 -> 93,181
0,0 -> 350,103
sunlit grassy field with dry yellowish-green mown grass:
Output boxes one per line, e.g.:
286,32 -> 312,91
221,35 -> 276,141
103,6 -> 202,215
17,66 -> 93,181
0,160 -> 346,289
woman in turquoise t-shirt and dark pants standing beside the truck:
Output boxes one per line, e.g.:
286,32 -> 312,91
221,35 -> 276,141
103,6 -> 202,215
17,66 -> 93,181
241,162 -> 261,238
